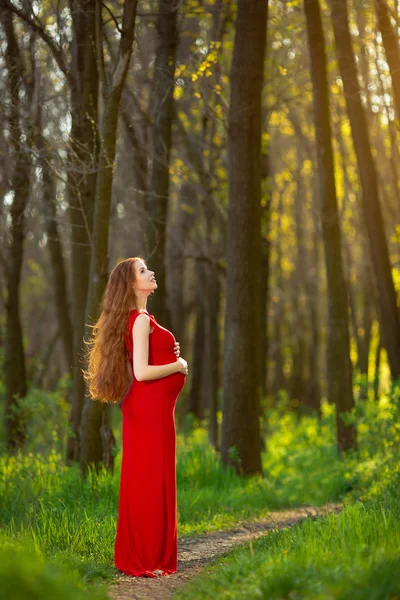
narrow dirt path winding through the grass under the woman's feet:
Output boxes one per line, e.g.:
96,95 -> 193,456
109,503 -> 343,600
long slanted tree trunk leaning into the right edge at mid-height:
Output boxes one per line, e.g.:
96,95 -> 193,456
329,0 -> 400,379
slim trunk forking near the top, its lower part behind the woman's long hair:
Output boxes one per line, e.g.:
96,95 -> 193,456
80,0 -> 137,475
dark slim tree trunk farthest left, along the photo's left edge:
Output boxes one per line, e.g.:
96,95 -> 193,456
0,1 -> 32,453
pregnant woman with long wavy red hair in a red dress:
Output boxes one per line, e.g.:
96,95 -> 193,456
86,257 -> 188,577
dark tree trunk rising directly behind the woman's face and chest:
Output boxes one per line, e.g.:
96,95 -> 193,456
147,0 -> 178,328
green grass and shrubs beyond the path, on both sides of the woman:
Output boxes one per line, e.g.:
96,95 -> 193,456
0,398 -> 350,578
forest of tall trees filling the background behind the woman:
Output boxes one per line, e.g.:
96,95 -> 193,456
0,0 -> 400,473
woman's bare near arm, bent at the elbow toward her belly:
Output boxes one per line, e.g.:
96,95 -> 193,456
132,313 -> 182,381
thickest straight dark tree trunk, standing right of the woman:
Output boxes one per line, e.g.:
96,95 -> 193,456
221,0 -> 268,474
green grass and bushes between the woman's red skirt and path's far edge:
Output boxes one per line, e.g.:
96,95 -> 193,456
177,413 -> 349,535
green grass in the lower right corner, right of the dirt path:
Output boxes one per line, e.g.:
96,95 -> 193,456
174,482 -> 400,600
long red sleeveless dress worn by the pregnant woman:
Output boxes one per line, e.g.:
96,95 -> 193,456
114,309 -> 186,577
